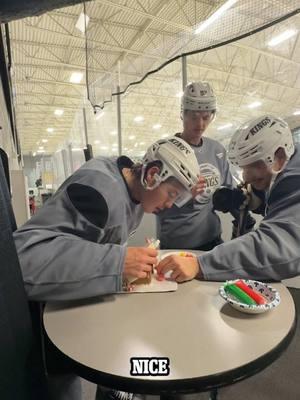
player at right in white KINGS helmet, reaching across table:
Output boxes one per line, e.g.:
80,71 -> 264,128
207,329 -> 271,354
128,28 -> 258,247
157,115 -> 300,281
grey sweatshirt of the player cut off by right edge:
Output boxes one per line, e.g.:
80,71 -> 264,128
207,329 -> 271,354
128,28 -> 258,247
199,145 -> 300,281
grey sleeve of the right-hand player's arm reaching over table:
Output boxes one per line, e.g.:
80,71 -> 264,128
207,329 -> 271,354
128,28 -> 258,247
198,198 -> 300,281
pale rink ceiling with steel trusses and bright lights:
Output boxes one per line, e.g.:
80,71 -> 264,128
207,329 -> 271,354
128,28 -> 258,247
9,0 -> 300,155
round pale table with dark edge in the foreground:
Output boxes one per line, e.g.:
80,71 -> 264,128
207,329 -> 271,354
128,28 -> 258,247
44,280 -> 295,394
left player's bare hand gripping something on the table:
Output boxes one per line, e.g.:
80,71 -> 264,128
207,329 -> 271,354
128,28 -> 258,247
123,247 -> 158,278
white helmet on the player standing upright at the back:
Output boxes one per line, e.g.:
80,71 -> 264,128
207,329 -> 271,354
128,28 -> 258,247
181,82 -> 217,113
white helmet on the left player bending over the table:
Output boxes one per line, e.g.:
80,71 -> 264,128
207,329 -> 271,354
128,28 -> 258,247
141,136 -> 200,207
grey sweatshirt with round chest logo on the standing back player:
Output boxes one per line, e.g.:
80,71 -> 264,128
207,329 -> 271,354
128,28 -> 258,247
157,137 -> 232,249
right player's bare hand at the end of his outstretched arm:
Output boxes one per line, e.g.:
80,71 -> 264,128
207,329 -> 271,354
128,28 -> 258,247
156,255 -> 202,282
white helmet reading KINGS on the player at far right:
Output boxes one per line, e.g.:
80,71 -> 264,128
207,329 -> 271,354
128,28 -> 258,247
228,115 -> 295,167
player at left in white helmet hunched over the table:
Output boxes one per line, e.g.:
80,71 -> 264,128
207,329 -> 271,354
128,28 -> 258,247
14,137 -> 201,400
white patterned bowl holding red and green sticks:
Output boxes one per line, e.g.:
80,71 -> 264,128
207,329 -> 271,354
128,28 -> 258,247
219,279 -> 280,314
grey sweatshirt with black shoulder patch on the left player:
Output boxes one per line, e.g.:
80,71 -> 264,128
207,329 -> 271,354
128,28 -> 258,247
14,157 -> 143,301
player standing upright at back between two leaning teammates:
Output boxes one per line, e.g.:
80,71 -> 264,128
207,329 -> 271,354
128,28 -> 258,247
158,82 -> 237,250
